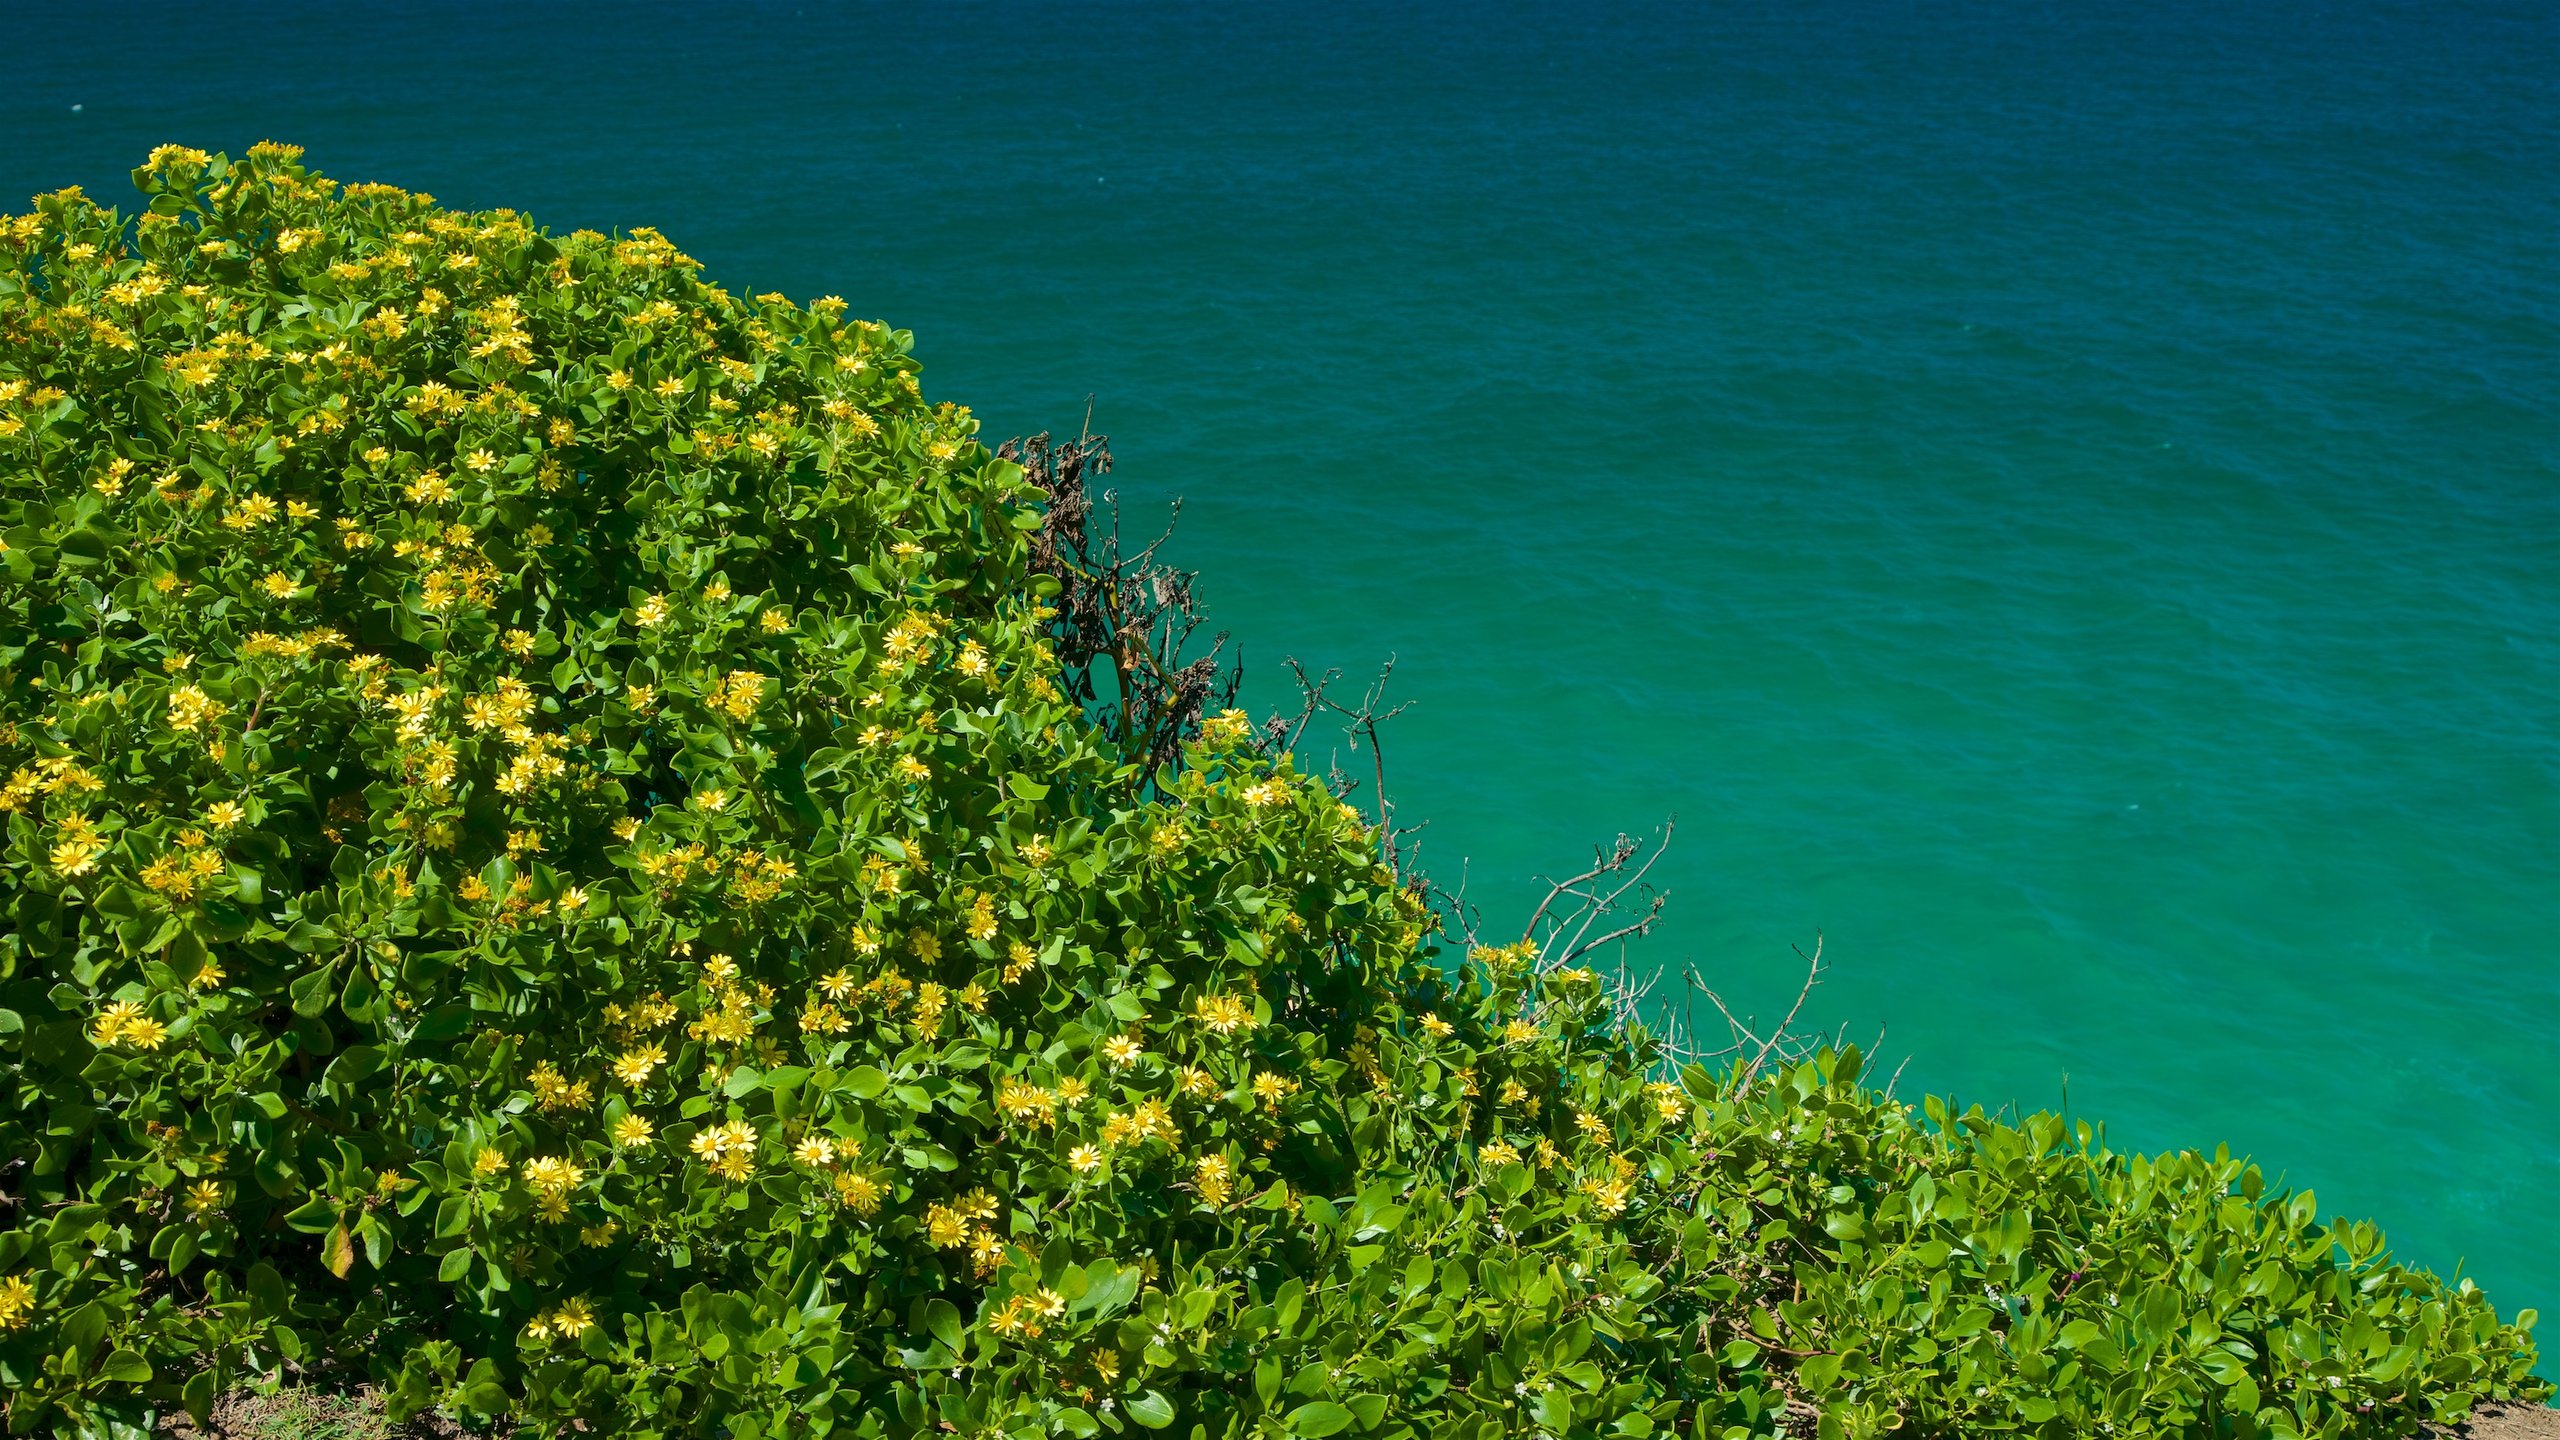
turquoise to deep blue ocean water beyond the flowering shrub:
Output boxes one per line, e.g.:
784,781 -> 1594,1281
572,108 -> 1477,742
20,0 -> 2560,1309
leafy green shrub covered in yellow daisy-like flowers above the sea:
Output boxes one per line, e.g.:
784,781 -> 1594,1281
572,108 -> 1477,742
0,146 -> 2542,1440
